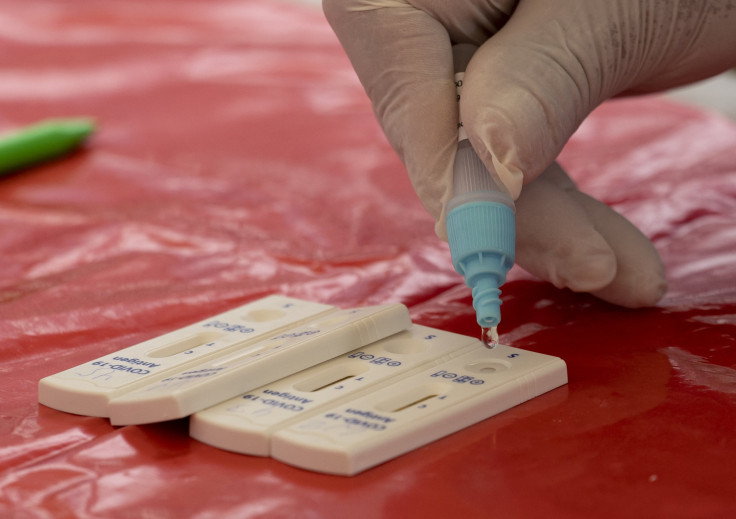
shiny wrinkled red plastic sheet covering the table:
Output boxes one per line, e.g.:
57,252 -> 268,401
0,0 -> 736,518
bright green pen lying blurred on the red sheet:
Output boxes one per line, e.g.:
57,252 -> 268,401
0,118 -> 95,176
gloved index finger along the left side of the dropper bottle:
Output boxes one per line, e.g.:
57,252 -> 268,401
323,0 -> 458,238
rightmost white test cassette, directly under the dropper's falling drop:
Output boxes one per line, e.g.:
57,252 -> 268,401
271,343 -> 567,476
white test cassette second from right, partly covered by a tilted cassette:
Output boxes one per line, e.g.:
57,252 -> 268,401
190,325 -> 478,456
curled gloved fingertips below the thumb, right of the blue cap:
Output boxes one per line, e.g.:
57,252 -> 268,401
516,163 -> 667,307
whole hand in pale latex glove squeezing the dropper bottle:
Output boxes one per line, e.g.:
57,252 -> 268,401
323,0 -> 736,307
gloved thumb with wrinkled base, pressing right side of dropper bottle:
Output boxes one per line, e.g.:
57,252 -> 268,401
460,0 -> 736,194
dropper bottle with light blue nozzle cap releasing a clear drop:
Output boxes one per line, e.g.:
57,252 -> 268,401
446,45 -> 516,348
